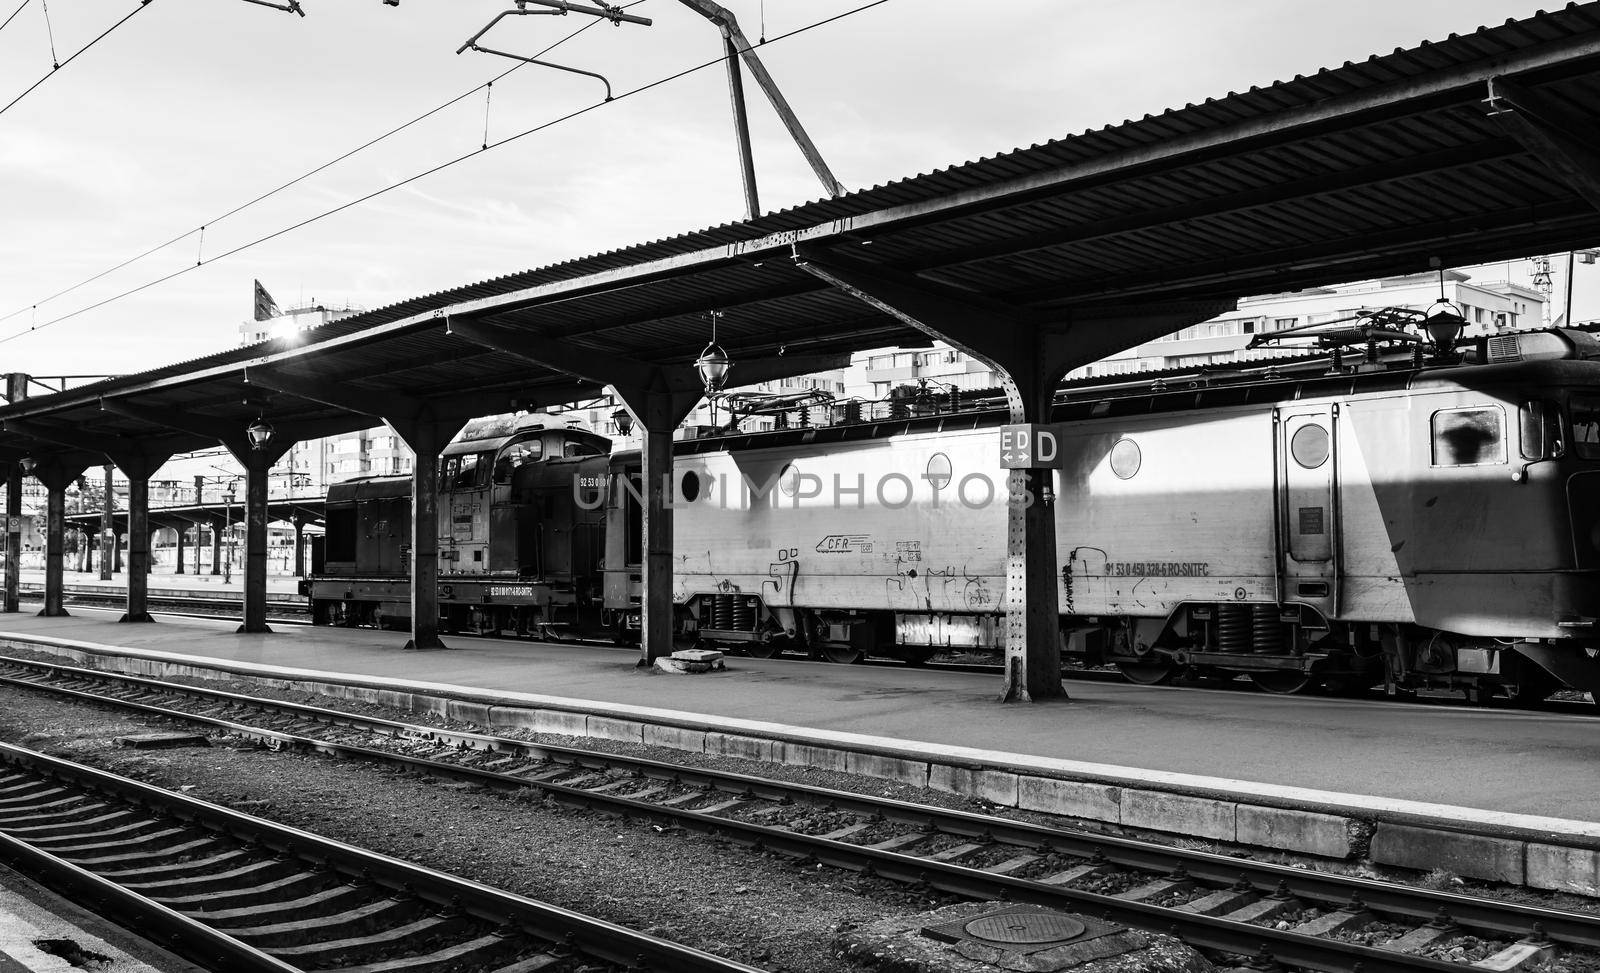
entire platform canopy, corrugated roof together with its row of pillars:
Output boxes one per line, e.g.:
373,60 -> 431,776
0,3 -> 1600,699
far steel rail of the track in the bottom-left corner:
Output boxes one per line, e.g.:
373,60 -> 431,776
0,743 -> 762,973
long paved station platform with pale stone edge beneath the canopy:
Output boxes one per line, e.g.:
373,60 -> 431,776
0,608 -> 1600,891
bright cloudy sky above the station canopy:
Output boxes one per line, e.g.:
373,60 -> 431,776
0,0 -> 1600,374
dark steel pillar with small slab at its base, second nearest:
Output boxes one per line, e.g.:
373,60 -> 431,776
614,386 -> 701,667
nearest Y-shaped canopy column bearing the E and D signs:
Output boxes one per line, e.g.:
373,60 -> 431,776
795,253 -> 1234,703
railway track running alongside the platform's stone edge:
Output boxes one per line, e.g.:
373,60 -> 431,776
0,658 -> 1600,973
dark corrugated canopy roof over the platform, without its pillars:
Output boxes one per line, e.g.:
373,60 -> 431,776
0,3 -> 1600,464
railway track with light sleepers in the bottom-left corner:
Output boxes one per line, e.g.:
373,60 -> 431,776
0,744 -> 768,973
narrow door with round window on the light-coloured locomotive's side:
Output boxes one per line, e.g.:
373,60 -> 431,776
1274,405 -> 1339,616
